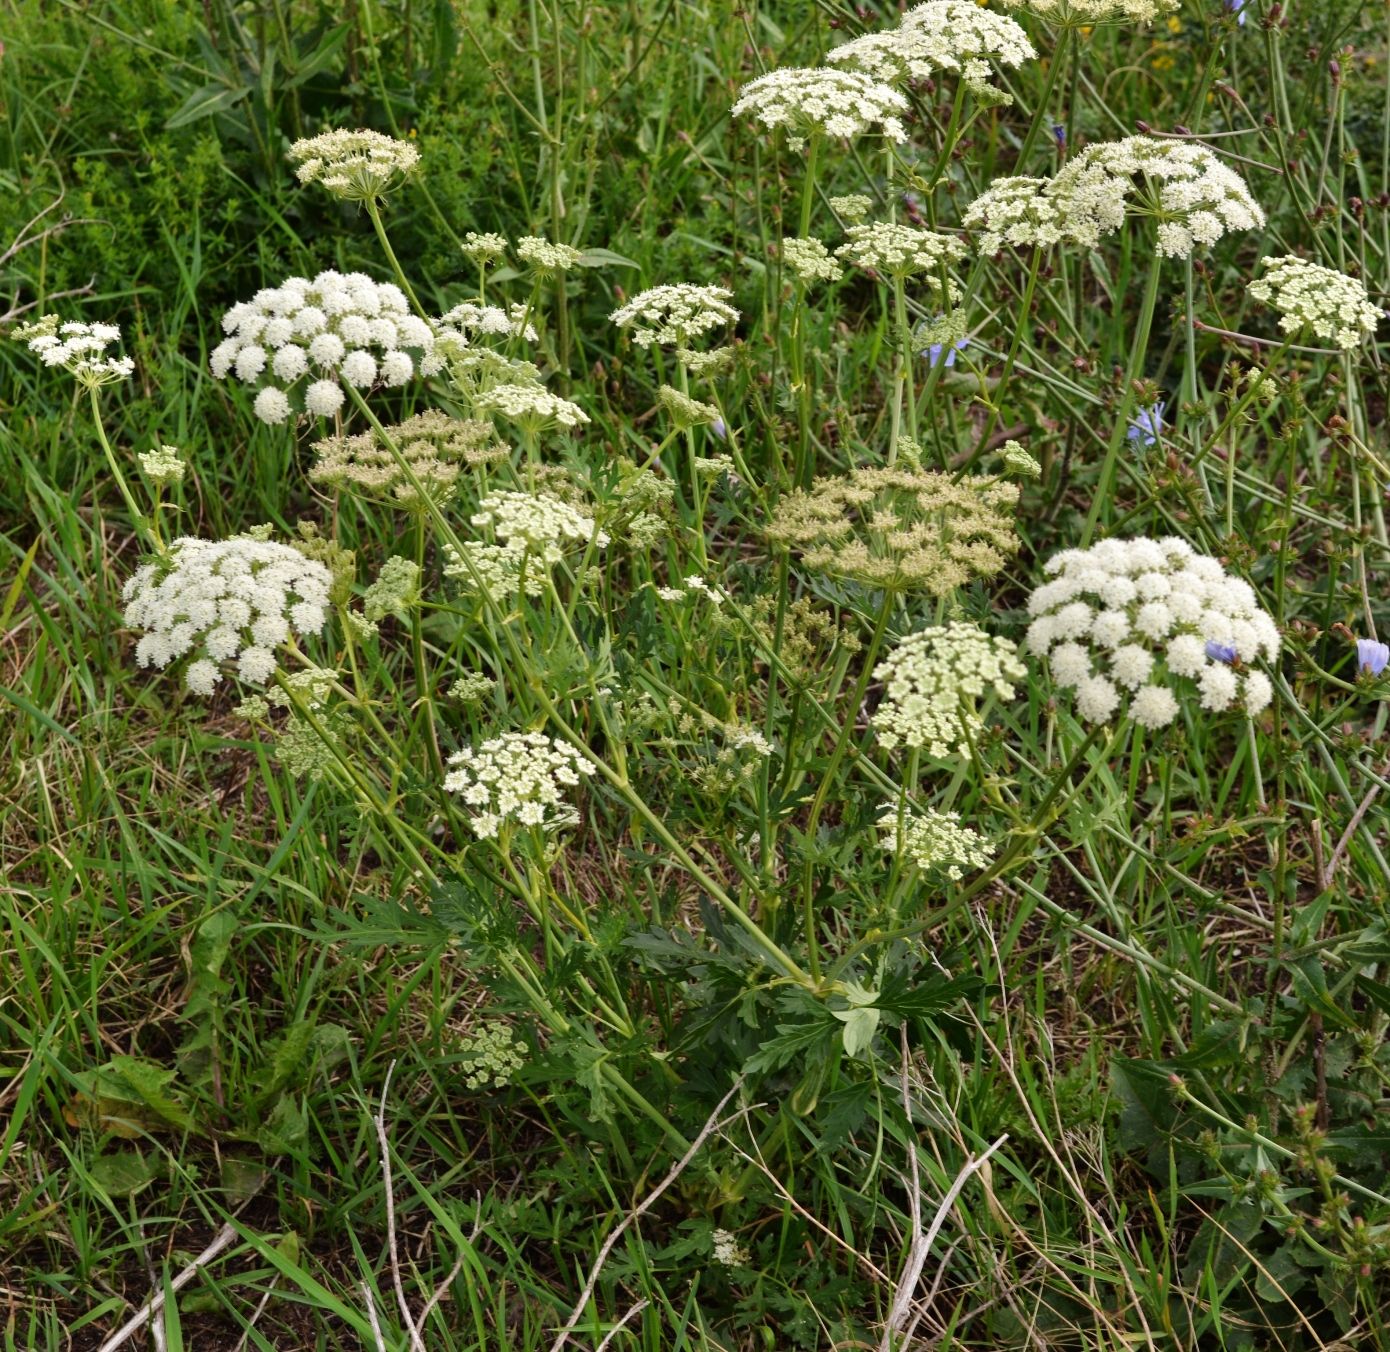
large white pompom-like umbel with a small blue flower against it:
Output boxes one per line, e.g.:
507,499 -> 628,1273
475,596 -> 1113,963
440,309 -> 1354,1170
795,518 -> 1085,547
1029,536 -> 1279,728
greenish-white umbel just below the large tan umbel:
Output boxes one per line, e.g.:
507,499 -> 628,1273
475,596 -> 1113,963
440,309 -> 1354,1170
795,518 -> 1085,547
873,621 -> 1027,760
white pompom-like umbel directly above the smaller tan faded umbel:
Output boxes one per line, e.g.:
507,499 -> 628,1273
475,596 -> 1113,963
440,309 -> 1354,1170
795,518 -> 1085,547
209,271 -> 434,424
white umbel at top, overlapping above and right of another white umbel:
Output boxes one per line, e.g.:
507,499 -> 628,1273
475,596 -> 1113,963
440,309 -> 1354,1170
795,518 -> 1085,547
826,0 -> 1037,88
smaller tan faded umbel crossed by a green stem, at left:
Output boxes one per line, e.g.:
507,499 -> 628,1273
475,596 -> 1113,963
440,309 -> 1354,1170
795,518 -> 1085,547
309,409 -> 507,509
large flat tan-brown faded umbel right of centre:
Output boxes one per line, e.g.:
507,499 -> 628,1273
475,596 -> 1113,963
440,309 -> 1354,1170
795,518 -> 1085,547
767,467 -> 1019,596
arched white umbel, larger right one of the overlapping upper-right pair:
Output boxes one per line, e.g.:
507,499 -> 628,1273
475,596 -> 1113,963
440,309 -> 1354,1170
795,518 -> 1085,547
1045,136 -> 1265,258
